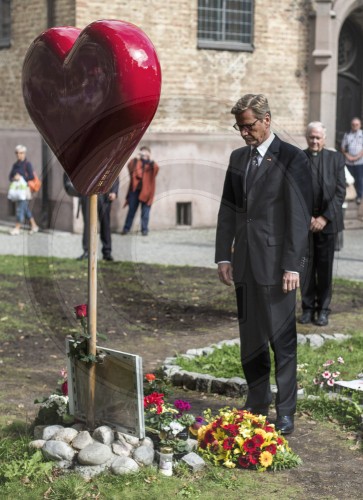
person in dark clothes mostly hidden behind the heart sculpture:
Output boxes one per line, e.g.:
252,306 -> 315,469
77,178 -> 120,262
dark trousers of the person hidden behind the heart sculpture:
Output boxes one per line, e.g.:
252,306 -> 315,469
81,194 -> 112,257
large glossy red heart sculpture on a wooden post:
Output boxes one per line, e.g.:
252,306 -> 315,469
23,20 -> 161,195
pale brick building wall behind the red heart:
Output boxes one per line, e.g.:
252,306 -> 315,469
0,0 -> 311,229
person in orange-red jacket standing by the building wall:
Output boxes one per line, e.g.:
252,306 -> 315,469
121,146 -> 159,236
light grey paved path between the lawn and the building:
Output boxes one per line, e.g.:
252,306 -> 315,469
0,223 -> 363,281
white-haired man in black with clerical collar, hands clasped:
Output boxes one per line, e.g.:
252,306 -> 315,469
299,122 -> 345,326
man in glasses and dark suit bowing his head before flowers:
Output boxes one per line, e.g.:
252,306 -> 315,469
216,94 -> 312,434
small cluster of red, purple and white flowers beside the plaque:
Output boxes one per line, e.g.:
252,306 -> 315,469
144,392 -> 195,452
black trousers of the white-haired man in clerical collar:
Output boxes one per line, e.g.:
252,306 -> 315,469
301,232 -> 336,312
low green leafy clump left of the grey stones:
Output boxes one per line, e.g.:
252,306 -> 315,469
0,450 -> 53,482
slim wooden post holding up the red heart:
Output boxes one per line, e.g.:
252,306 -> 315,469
87,194 -> 98,430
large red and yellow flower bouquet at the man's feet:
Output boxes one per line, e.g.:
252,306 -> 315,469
198,407 -> 301,471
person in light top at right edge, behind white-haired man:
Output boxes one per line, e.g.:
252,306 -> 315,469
341,118 -> 363,205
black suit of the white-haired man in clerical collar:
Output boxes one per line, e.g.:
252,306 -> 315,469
302,149 -> 346,313
